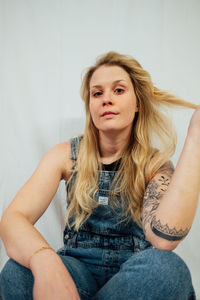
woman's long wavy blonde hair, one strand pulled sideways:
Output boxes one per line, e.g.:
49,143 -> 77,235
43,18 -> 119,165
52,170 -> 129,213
66,51 -> 197,231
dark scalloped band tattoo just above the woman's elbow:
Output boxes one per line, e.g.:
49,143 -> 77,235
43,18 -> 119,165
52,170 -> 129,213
151,216 -> 189,241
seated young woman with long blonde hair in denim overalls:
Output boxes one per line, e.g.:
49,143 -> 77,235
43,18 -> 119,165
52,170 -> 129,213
0,52 -> 200,300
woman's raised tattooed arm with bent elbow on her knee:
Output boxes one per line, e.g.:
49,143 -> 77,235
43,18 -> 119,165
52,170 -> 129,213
143,106 -> 200,250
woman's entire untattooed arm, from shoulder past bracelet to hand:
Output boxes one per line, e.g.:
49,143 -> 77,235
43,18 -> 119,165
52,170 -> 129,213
0,142 -> 80,300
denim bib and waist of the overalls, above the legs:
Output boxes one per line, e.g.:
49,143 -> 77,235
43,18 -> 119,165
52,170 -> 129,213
61,137 -> 151,252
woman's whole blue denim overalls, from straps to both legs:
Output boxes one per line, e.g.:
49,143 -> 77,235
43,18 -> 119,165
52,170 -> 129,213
0,138 -> 196,300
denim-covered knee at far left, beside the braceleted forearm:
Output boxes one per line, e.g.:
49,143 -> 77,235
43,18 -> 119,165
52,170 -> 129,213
0,259 -> 33,300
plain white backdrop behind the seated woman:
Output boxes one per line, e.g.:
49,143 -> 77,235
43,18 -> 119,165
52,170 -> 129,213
0,0 -> 200,299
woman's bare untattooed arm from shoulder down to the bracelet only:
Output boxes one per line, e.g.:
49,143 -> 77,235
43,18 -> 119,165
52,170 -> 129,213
0,143 -> 69,267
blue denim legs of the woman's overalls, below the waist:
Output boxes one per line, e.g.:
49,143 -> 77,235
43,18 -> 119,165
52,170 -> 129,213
0,248 -> 196,300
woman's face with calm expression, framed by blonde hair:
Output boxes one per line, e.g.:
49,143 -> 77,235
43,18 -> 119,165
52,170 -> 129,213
89,65 -> 138,133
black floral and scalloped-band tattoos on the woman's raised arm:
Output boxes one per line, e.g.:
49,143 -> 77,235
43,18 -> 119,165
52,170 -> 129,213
143,161 -> 189,241
